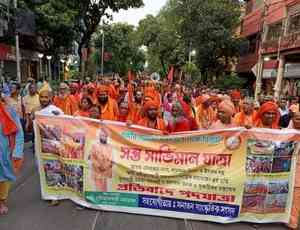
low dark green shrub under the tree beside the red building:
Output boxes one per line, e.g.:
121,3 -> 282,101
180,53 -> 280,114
215,74 -> 247,89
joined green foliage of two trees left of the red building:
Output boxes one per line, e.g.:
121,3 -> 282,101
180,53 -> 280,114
138,0 -> 242,79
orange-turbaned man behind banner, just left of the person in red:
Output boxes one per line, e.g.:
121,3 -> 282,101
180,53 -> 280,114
138,100 -> 166,131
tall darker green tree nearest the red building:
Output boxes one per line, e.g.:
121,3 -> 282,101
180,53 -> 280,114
175,0 -> 242,80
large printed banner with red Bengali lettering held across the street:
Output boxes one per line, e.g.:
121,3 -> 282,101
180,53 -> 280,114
35,115 -> 299,223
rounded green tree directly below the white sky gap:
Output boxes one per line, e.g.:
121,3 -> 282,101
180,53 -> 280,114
93,23 -> 145,75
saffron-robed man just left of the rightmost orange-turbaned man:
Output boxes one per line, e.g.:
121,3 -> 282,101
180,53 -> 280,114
233,98 -> 256,128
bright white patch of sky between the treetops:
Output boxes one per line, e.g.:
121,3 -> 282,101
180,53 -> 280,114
113,0 -> 167,26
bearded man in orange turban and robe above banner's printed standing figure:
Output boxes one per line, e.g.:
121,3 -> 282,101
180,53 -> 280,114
97,85 -> 119,121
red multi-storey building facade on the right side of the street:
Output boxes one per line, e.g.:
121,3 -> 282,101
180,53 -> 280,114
236,0 -> 300,98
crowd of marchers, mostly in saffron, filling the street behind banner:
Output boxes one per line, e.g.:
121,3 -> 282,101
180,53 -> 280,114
0,73 -> 300,228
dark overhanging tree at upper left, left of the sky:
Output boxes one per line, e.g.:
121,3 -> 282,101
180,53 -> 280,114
23,0 -> 143,75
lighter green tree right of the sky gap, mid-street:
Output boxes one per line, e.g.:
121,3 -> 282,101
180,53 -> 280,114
138,5 -> 185,75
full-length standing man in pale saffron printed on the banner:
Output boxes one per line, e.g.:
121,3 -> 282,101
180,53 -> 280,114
90,128 -> 113,192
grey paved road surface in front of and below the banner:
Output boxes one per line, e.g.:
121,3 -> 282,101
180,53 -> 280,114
0,148 -> 287,230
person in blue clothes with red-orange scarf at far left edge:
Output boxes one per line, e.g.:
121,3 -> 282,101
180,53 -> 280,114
0,92 -> 24,216
